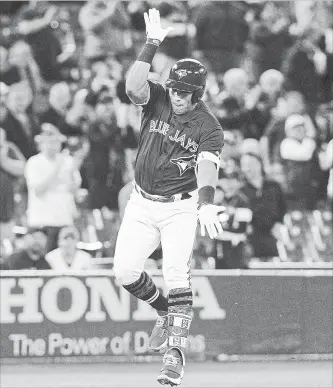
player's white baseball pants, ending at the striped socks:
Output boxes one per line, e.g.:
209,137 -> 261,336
114,188 -> 197,290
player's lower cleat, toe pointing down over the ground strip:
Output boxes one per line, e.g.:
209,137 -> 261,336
157,348 -> 185,387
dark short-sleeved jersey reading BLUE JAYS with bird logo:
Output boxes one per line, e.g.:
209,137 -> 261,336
135,81 -> 223,196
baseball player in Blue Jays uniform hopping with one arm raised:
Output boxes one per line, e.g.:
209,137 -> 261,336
114,9 -> 224,386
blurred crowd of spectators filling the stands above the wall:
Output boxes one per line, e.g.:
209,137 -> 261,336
0,0 -> 333,271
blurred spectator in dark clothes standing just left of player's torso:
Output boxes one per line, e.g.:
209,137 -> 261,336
87,88 -> 124,210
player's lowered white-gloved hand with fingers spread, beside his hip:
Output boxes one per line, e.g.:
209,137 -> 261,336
198,205 -> 226,238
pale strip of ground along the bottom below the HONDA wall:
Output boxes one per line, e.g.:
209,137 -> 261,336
0,361 -> 333,388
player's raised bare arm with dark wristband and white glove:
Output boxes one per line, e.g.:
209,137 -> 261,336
126,8 -> 172,105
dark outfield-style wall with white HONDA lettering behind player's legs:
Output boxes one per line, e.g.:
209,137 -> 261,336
0,270 -> 333,363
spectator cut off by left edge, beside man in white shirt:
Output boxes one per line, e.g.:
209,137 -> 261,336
0,128 -> 25,253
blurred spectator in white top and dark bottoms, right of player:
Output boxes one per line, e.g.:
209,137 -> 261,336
280,115 -> 317,210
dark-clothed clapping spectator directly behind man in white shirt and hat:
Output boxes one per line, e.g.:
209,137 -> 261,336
40,82 -> 82,136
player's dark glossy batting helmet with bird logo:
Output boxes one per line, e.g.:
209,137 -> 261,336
165,58 -> 207,102
